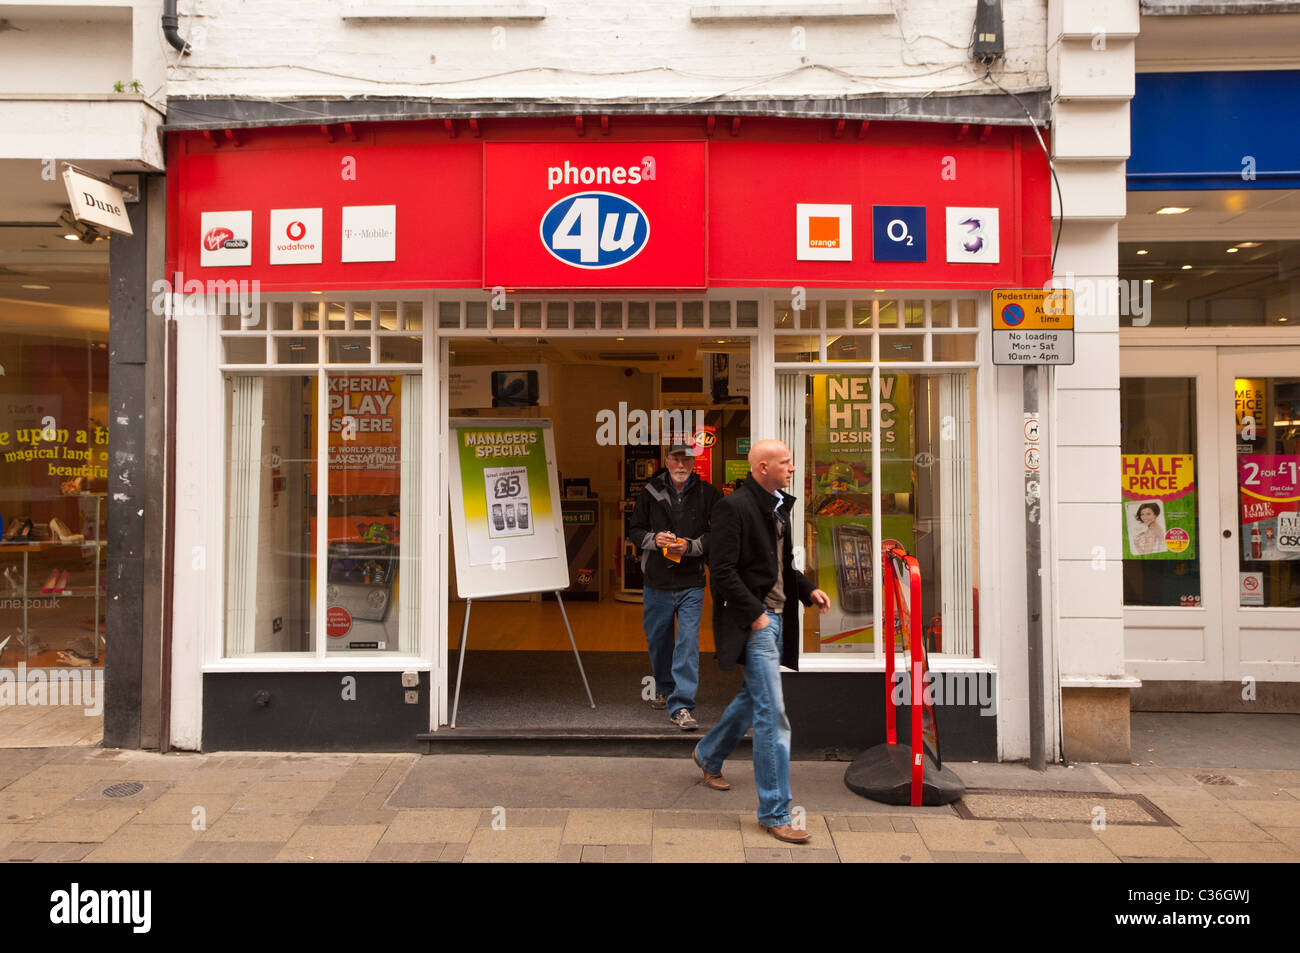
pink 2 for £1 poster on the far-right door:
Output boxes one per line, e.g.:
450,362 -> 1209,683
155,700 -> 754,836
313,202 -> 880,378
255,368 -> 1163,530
1236,454 -> 1300,562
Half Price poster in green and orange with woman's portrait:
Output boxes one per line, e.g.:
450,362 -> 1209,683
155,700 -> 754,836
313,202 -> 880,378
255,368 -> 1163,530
1121,454 -> 1196,559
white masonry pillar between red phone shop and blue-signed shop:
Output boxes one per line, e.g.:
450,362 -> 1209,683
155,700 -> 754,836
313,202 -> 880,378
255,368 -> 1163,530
1044,0 -> 1140,728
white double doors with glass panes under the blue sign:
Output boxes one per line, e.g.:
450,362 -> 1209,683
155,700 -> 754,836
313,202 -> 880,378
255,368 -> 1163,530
1121,347 -> 1300,691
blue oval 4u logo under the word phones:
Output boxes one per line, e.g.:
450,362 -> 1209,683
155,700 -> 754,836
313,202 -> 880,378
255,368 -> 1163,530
541,192 -> 650,269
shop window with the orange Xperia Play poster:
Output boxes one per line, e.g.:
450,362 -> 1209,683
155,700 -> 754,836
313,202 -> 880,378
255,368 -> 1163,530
225,373 -> 423,658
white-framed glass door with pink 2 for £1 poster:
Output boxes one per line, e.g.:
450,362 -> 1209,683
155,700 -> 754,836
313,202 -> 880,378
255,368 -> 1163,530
1217,348 -> 1300,681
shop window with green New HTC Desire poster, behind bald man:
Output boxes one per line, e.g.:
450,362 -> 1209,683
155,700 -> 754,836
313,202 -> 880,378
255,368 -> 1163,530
777,369 -> 979,658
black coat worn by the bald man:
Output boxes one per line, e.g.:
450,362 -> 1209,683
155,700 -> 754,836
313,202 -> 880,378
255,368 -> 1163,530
709,476 -> 816,670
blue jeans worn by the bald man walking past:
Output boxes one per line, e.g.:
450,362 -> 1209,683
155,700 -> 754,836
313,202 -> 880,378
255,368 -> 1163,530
696,612 -> 790,827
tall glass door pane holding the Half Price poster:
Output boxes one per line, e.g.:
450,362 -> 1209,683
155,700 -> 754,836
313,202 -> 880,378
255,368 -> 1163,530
1117,377 -> 1203,606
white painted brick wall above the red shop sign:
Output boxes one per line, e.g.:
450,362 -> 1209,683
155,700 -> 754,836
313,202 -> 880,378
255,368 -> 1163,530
169,0 -> 1050,104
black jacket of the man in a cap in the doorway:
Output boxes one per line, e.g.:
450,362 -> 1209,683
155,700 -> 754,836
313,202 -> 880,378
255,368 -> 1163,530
628,469 -> 722,590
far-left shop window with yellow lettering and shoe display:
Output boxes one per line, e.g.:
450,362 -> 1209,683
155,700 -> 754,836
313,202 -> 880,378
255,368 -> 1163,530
0,332 -> 109,670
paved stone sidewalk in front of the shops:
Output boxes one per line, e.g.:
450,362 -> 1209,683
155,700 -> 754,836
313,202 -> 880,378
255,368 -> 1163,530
0,715 -> 1300,863
